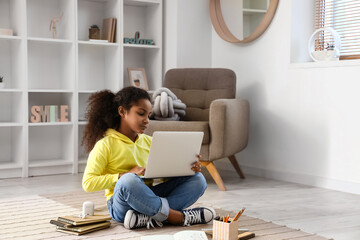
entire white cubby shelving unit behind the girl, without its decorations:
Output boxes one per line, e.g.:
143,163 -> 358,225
0,0 -> 163,179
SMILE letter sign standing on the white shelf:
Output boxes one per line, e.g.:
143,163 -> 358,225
30,105 -> 69,123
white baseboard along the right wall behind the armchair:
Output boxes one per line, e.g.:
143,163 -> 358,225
217,164 -> 360,195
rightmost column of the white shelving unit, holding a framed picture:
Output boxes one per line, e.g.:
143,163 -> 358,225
123,0 -> 162,89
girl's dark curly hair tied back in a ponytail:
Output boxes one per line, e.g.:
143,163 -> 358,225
81,87 -> 151,152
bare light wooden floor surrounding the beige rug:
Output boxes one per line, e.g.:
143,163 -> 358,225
0,171 -> 360,240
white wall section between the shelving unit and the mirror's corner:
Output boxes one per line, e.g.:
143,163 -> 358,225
163,0 -> 212,72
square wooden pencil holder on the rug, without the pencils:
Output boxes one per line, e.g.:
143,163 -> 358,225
213,220 -> 238,240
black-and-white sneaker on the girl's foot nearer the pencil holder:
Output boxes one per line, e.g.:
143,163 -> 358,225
182,207 -> 215,226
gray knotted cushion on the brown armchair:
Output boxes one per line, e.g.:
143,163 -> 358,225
153,88 -> 186,121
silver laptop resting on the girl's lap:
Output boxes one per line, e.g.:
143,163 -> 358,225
143,131 -> 204,178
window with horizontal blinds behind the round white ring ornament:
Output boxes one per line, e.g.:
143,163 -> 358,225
315,0 -> 360,59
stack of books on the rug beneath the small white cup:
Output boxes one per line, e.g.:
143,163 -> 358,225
50,215 -> 111,235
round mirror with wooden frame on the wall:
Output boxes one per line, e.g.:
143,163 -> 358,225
210,0 -> 279,43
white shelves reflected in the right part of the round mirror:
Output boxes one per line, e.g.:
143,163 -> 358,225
242,0 -> 270,38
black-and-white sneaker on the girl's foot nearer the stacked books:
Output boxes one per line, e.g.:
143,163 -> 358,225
124,210 -> 162,229
